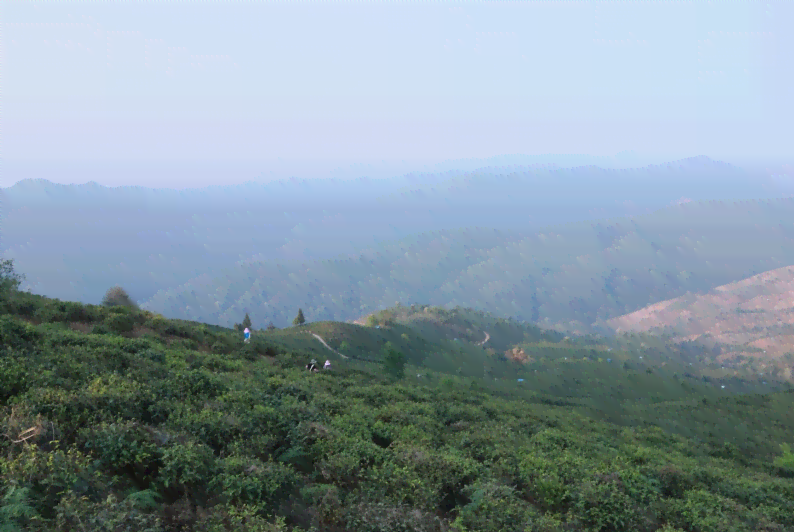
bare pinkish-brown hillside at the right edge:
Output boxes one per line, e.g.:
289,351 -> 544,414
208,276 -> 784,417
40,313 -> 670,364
608,266 -> 794,379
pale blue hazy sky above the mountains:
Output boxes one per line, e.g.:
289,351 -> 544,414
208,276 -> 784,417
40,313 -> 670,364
0,1 -> 794,188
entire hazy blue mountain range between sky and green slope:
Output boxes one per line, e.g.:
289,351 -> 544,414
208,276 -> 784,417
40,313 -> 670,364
0,157 -> 794,332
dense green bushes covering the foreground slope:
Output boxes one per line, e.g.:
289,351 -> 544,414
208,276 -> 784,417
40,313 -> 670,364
0,262 -> 794,532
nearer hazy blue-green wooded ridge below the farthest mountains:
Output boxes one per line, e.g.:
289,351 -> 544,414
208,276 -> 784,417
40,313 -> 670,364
143,198 -> 794,335
